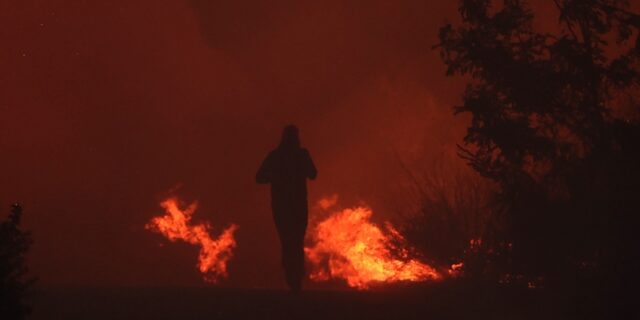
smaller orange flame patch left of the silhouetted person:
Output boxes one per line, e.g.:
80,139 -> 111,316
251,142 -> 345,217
145,198 -> 238,283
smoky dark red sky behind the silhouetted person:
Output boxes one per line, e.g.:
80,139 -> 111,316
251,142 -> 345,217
0,0 -> 480,287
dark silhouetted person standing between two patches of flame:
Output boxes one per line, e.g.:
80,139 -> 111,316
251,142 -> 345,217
256,125 -> 317,291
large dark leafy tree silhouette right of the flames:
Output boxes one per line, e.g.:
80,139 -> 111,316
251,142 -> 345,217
437,0 -> 640,308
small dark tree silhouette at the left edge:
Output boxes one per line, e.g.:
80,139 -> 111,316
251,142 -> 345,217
0,204 -> 34,319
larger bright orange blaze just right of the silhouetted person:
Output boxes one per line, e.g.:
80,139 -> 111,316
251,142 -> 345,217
305,198 -> 442,289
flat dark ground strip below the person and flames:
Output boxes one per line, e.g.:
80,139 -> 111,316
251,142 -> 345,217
31,285 -> 566,319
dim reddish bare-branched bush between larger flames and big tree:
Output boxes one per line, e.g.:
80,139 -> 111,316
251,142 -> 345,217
402,170 -> 510,279
